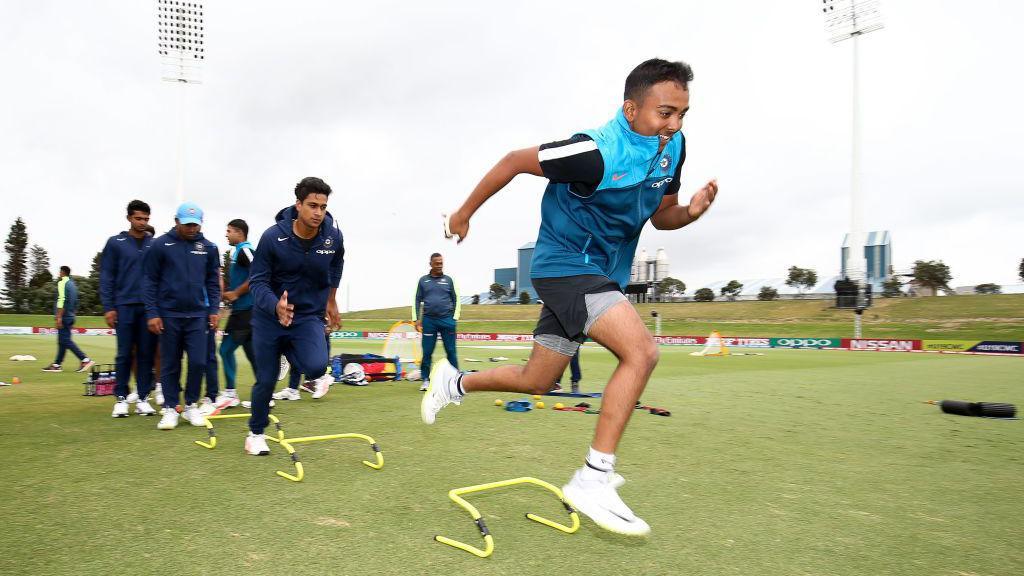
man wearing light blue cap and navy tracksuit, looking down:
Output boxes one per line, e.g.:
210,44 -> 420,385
142,202 -> 220,430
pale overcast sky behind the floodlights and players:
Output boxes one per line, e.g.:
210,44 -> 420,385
0,0 -> 1024,310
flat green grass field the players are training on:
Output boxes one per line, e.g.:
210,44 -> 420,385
0,336 -> 1024,576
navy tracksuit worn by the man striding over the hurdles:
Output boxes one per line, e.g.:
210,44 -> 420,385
249,206 -> 345,434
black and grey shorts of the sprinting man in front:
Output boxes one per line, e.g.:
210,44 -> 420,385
532,276 -> 626,356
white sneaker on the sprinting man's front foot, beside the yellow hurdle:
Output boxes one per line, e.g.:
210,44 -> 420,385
562,469 -> 650,536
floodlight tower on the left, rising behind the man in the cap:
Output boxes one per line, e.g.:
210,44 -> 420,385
157,0 -> 206,203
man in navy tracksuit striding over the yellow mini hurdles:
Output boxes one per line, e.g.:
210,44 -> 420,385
245,176 -> 345,456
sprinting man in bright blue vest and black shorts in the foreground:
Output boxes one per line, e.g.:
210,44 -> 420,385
421,59 -> 718,536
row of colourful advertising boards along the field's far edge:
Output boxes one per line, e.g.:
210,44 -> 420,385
6,326 -> 1024,357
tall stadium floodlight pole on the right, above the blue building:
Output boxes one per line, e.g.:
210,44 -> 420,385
821,0 -> 883,338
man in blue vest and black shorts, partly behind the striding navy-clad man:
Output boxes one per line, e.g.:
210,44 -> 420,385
217,218 -> 256,408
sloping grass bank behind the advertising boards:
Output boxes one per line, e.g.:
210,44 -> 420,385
0,294 -> 1024,340
